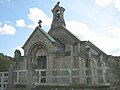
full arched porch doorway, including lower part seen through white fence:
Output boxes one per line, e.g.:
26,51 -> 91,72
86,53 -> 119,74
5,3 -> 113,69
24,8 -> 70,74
29,43 -> 48,83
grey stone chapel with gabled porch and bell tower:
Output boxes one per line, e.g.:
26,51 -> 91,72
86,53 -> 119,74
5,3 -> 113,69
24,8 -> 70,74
7,2 -> 120,90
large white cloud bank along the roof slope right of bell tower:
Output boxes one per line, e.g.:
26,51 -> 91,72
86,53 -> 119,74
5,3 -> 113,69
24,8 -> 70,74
66,21 -> 120,55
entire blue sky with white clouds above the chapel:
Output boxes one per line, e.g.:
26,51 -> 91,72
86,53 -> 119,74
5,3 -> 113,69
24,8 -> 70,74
0,0 -> 120,56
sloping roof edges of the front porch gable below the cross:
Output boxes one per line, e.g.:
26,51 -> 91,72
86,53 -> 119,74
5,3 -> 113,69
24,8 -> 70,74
22,26 -> 59,49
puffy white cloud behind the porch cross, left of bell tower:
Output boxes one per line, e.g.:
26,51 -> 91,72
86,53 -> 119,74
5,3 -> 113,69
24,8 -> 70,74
28,7 -> 52,26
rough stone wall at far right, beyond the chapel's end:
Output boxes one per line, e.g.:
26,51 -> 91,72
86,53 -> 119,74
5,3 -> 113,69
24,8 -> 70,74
108,56 -> 120,90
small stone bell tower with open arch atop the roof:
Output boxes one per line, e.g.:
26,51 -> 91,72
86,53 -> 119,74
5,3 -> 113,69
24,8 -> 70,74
51,2 -> 66,28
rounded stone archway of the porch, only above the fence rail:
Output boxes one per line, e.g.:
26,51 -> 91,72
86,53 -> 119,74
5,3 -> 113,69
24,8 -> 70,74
28,43 -> 47,69
